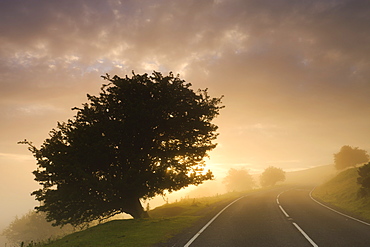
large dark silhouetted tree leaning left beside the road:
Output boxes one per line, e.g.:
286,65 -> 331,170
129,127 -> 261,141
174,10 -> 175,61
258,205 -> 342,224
21,72 -> 223,225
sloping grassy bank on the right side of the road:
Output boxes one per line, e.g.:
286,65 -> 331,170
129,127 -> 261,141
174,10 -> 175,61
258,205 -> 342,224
312,168 -> 370,222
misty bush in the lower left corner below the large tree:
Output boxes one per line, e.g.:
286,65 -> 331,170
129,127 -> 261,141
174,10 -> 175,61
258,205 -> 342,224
2,211 -> 74,246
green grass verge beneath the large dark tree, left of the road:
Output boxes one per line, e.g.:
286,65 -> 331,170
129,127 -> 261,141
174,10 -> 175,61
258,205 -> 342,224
42,192 -> 246,247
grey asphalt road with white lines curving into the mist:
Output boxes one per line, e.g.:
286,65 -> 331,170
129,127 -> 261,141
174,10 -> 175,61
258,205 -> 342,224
170,187 -> 370,247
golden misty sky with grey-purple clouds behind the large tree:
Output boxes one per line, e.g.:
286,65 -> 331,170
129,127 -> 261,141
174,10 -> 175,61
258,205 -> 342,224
0,0 -> 370,232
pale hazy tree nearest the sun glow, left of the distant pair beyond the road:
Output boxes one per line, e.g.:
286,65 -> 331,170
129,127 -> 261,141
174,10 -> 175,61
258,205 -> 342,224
223,168 -> 255,191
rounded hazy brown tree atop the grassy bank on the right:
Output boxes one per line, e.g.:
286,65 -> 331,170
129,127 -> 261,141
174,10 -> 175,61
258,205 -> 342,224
334,145 -> 369,170
